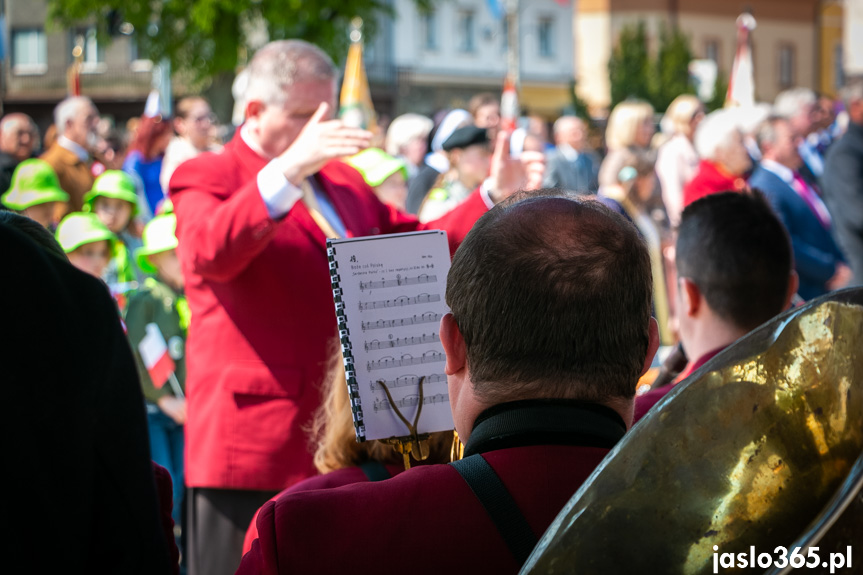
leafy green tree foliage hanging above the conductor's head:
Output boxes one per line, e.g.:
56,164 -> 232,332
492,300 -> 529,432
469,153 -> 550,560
48,0 -> 422,96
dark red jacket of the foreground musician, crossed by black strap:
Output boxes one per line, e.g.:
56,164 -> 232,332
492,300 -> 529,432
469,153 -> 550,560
237,445 -> 608,575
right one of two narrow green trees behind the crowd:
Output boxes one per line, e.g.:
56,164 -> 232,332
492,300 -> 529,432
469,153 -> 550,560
650,24 -> 695,112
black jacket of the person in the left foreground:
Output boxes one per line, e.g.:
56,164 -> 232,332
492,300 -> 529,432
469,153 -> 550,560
0,224 -> 172,575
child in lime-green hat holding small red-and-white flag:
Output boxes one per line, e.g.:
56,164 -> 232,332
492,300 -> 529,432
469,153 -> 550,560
126,214 -> 190,525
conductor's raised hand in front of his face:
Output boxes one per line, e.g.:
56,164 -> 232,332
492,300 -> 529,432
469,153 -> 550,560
278,102 -> 372,186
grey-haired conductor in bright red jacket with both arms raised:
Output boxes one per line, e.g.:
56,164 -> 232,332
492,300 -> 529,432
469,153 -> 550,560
170,40 -> 544,575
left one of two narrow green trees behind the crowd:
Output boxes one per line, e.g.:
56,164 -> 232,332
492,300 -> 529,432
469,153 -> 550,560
608,21 -> 651,107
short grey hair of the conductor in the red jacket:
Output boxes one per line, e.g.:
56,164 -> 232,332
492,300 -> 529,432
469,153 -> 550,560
243,40 -> 336,104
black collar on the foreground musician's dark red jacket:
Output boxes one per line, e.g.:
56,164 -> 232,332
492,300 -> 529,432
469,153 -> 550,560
464,399 -> 626,457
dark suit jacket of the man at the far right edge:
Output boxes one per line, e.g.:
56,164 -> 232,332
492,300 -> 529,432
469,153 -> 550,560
822,122 -> 863,285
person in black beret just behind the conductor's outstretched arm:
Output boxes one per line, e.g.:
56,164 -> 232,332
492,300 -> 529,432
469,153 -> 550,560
419,125 -> 492,222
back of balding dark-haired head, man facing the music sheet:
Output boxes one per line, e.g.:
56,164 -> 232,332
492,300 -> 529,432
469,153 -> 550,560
446,190 -> 652,403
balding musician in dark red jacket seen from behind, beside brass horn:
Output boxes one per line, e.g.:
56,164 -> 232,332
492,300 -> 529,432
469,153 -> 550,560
237,194 -> 659,575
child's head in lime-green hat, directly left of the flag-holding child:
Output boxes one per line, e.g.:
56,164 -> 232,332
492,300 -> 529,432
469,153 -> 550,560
54,212 -> 117,278
